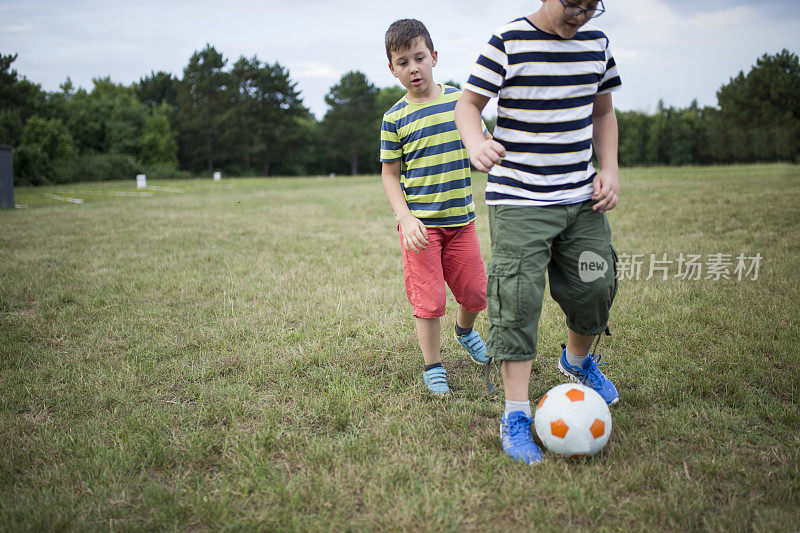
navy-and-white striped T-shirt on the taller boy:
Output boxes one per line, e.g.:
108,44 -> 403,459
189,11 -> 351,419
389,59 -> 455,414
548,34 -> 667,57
466,17 -> 621,205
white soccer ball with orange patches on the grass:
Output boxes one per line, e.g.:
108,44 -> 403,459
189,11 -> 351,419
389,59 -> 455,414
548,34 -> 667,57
533,383 -> 611,457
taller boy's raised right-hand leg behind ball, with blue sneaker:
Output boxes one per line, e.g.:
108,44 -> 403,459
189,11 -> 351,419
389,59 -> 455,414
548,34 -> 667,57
549,202 -> 619,405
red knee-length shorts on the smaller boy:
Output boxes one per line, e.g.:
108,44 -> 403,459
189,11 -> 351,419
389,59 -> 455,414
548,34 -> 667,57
400,222 -> 486,318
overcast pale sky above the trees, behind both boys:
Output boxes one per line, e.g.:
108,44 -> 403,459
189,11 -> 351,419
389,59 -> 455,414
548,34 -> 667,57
0,0 -> 800,118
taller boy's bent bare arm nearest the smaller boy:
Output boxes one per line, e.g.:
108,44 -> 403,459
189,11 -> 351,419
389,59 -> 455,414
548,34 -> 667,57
455,89 -> 506,172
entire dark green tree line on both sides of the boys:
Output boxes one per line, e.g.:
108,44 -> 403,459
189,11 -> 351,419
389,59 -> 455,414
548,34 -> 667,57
0,45 -> 800,184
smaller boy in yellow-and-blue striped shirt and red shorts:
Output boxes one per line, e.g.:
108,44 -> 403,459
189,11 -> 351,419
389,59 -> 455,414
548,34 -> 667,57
381,19 -> 488,395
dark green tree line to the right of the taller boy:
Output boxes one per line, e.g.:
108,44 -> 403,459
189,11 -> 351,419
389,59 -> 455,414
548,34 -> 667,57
617,49 -> 800,165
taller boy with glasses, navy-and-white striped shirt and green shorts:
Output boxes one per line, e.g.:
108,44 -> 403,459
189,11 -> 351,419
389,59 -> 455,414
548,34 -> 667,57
455,0 -> 620,464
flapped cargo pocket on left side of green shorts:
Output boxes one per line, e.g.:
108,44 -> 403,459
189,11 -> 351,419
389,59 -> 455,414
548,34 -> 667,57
486,256 -> 526,328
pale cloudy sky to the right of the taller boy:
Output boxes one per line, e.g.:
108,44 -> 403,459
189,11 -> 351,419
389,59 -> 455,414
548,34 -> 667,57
608,0 -> 800,111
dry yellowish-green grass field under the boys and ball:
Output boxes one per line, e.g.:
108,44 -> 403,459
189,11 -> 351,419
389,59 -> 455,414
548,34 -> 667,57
0,165 -> 800,531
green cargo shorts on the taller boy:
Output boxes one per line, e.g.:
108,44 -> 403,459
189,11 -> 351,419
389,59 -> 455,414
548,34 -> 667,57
486,201 -> 617,361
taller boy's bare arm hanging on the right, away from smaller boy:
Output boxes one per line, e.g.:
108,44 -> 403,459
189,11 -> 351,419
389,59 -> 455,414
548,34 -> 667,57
592,93 -> 619,213
